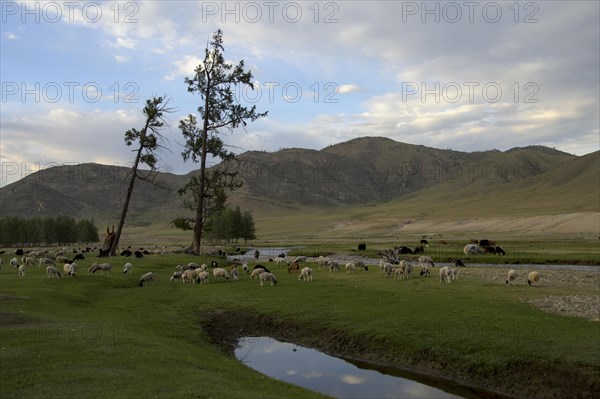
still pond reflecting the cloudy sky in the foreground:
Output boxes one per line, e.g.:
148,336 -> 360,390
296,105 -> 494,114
235,337 -> 461,399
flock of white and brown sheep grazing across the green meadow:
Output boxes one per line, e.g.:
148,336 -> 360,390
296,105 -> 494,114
0,243 -> 540,287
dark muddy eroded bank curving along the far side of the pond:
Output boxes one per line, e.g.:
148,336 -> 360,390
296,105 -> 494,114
201,310 -> 600,399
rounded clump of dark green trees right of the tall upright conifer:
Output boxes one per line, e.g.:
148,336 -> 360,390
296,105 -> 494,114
207,206 -> 256,243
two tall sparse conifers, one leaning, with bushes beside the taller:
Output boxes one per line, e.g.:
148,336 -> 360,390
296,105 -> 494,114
113,29 -> 267,255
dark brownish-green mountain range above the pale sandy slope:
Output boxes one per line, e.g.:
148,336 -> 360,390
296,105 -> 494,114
0,137 -> 600,234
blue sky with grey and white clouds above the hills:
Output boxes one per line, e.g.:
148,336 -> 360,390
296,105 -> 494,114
0,1 -> 600,185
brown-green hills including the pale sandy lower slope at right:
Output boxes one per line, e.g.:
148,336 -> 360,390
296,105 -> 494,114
0,137 -> 600,240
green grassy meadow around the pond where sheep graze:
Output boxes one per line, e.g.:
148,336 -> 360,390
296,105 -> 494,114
0,242 -> 600,398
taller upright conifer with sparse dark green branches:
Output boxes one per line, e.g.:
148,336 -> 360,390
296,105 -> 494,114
173,29 -> 267,253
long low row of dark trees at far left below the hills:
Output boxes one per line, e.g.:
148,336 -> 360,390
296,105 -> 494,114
0,216 -> 100,246
